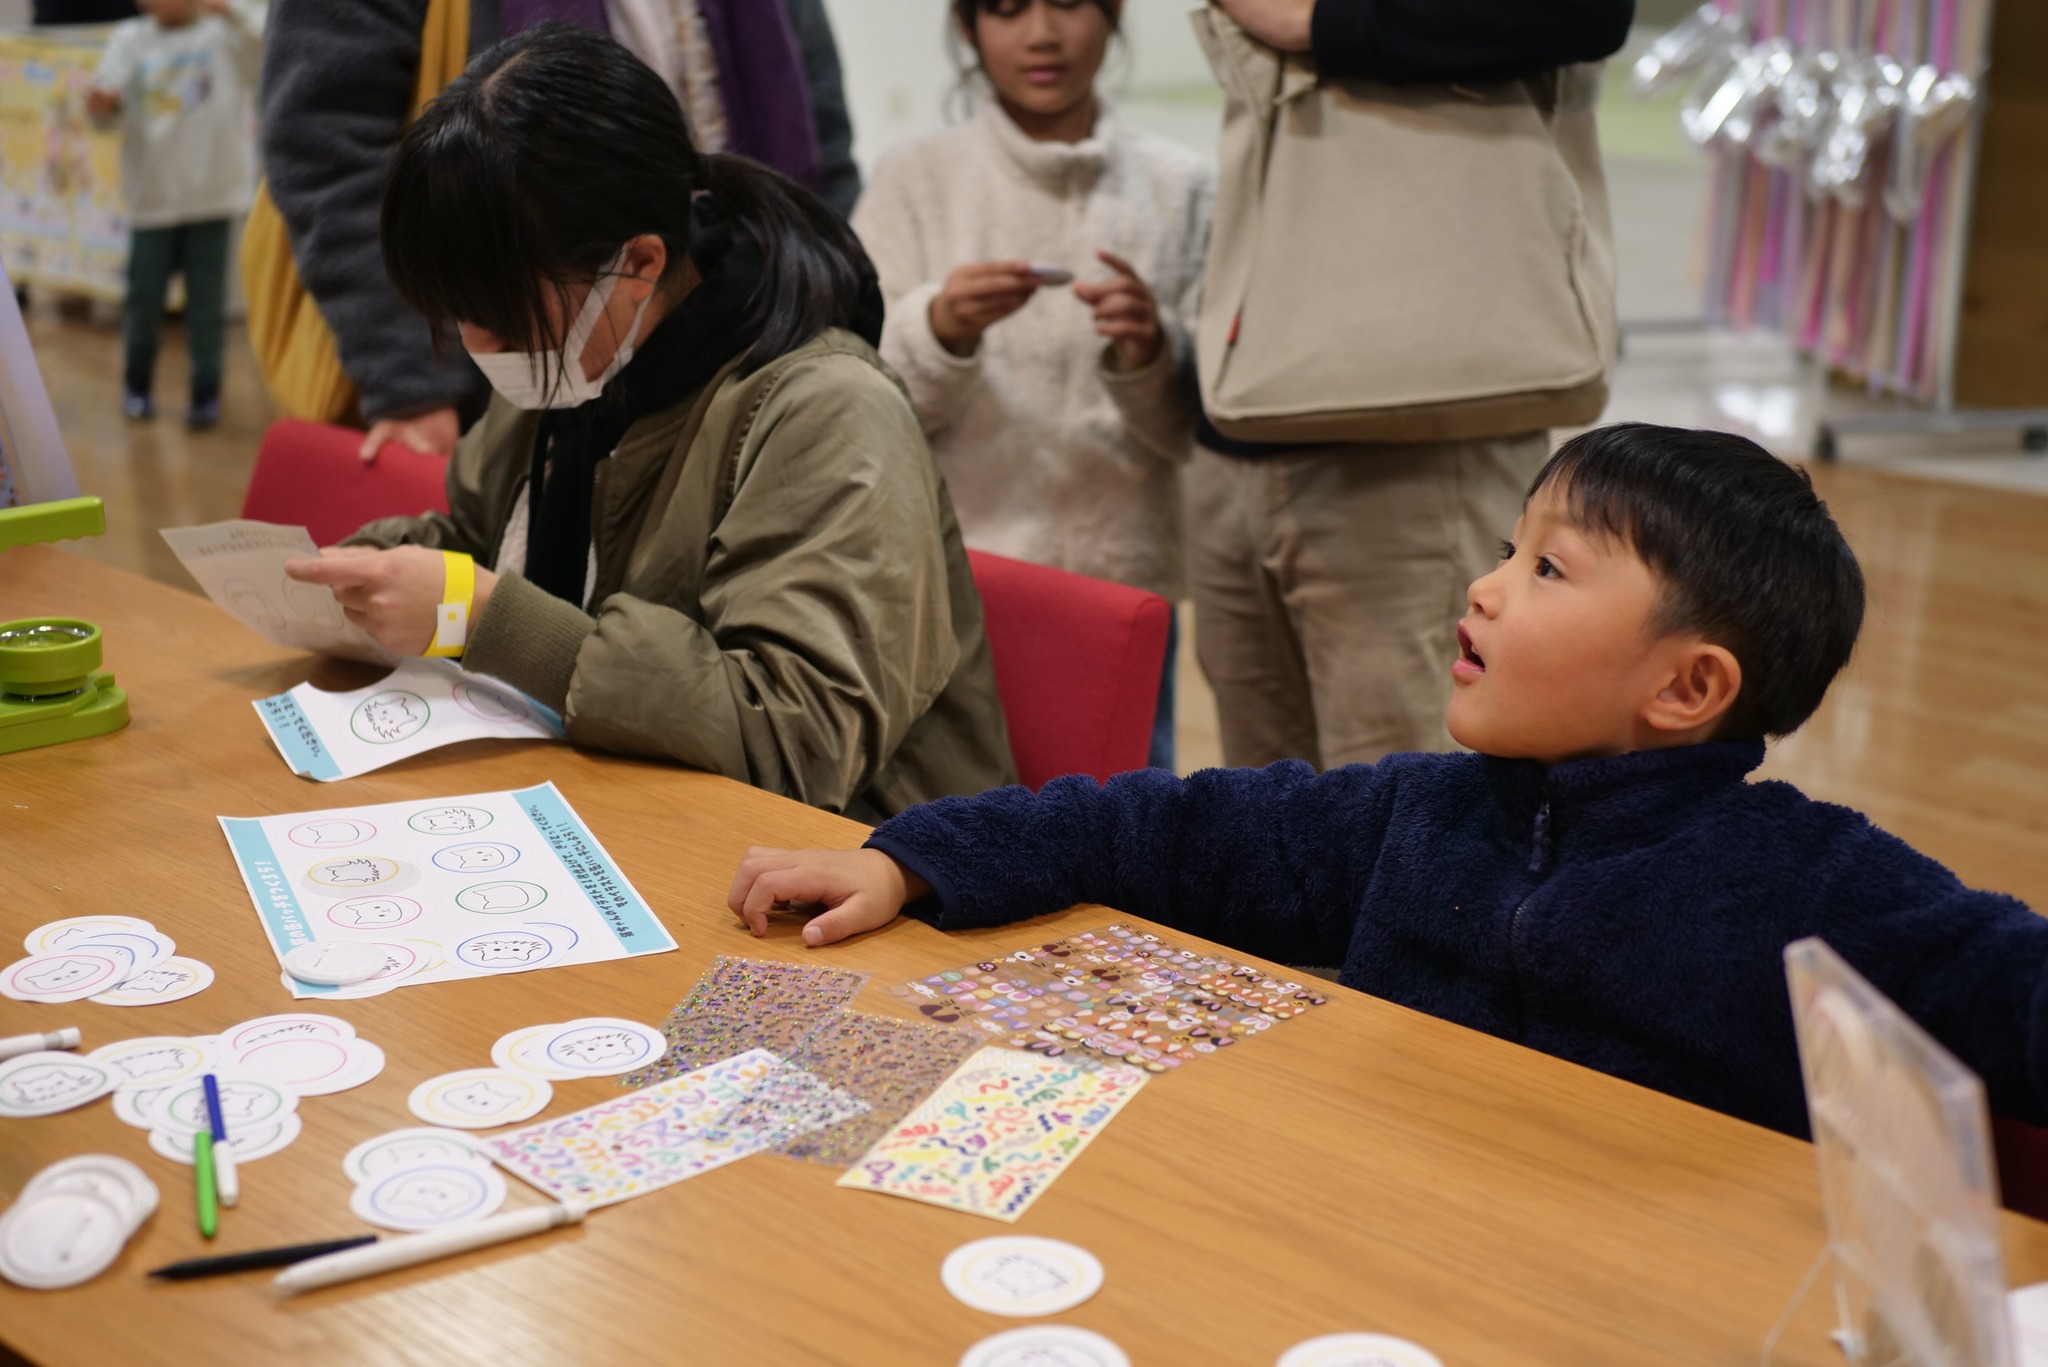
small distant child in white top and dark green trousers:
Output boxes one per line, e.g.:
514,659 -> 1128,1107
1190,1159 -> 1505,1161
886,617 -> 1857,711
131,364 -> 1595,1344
88,0 -> 264,428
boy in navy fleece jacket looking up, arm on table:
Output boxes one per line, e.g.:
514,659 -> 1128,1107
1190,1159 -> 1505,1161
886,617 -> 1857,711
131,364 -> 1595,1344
731,424 -> 2048,1135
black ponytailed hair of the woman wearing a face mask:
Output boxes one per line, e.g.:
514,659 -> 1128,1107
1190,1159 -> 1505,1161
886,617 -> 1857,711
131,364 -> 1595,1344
381,20 -> 874,387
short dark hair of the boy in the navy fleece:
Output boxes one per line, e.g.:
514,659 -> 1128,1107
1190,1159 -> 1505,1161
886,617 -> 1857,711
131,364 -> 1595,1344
1530,422 -> 1864,740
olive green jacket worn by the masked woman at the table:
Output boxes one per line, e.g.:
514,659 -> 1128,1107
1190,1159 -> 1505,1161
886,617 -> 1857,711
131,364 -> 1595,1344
350,330 -> 1016,822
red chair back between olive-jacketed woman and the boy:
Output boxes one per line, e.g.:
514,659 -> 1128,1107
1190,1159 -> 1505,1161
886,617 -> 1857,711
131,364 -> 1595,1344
967,551 -> 1174,789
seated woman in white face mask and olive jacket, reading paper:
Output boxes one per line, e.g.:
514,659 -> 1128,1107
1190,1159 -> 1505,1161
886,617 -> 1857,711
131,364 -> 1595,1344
291,25 -> 1014,820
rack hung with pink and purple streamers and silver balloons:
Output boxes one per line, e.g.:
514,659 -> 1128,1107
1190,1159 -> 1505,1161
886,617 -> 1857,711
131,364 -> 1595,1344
1632,0 -> 2048,459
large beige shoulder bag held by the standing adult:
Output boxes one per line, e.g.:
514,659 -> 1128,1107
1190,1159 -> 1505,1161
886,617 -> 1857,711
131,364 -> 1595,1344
1194,6 -> 1616,443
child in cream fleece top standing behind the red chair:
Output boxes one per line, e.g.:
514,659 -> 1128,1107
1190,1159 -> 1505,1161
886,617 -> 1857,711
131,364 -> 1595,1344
854,0 -> 1212,769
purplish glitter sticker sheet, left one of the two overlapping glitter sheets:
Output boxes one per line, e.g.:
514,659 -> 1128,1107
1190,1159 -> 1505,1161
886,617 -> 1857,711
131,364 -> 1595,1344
623,955 -> 868,1086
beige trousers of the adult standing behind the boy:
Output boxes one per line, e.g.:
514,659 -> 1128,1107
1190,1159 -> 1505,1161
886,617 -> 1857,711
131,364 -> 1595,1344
1188,432 -> 1550,769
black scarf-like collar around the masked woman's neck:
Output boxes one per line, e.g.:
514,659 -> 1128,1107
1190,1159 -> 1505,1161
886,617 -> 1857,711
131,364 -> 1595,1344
526,211 -> 762,607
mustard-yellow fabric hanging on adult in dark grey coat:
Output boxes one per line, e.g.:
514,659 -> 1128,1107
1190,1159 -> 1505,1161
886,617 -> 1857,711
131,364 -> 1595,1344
242,0 -> 469,422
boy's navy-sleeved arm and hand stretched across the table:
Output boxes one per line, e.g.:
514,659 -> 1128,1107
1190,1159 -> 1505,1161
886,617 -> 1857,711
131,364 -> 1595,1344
731,762 -> 1386,965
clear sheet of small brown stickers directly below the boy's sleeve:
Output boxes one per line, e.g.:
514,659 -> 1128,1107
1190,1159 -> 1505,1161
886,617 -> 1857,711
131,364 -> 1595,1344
889,924 -> 1327,1072
